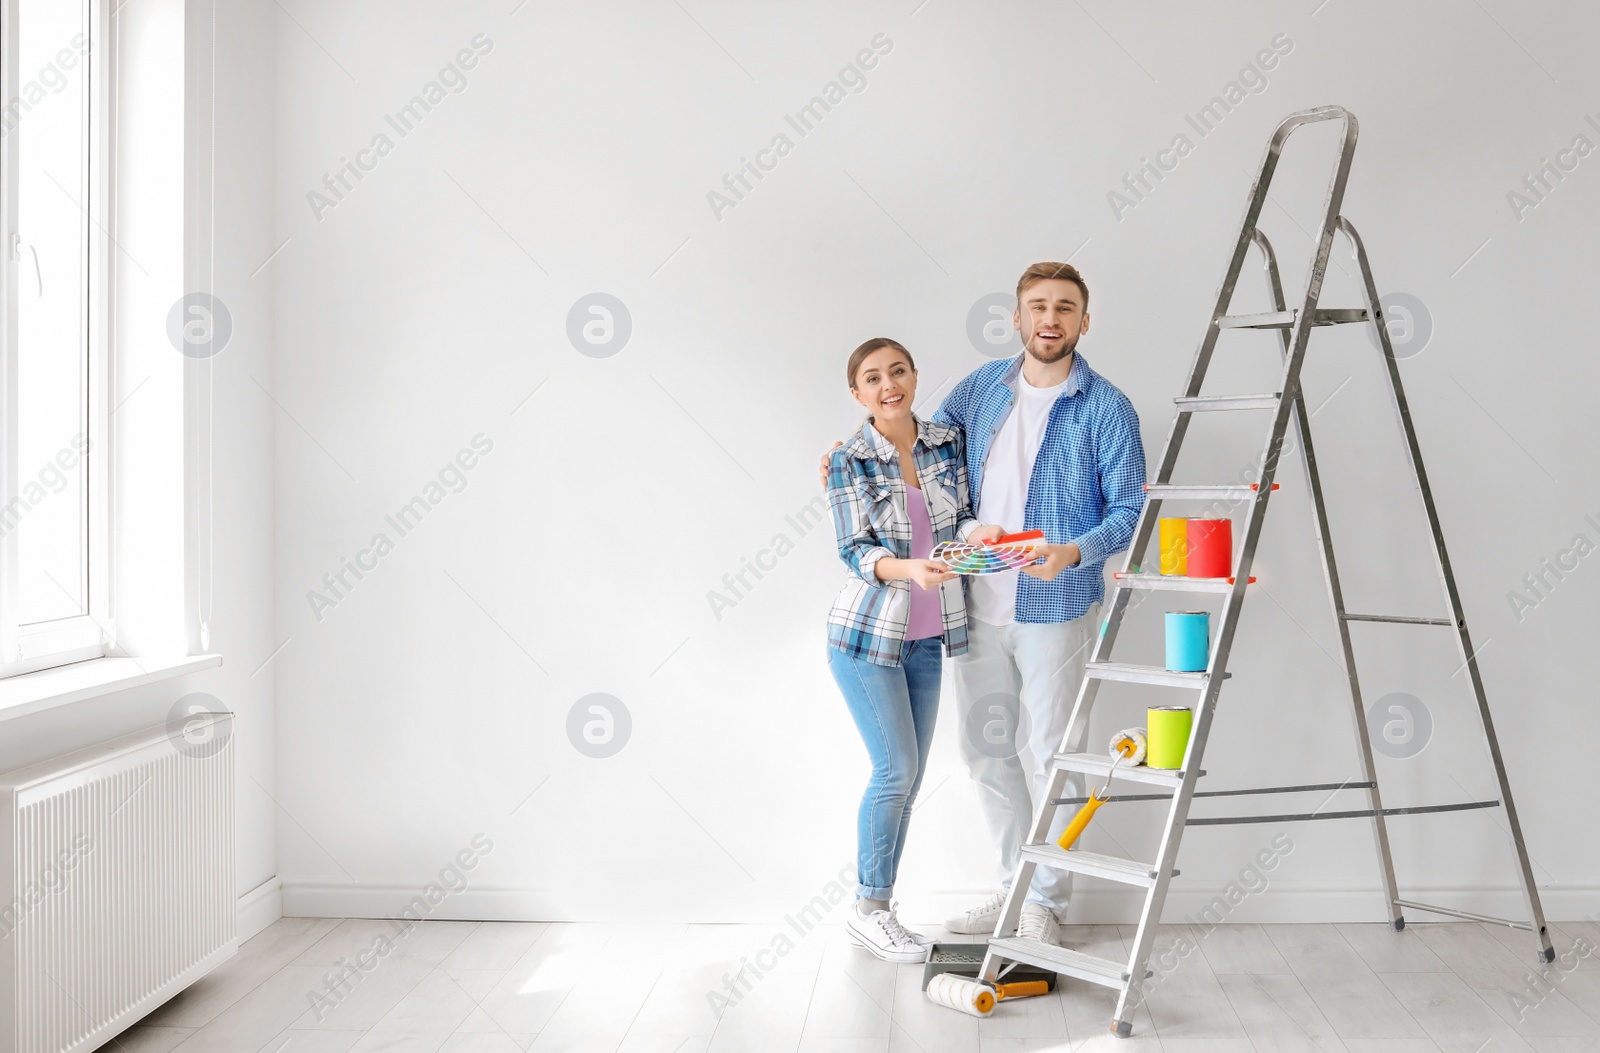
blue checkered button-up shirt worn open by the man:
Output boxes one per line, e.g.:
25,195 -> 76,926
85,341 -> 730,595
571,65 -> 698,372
933,352 -> 1144,623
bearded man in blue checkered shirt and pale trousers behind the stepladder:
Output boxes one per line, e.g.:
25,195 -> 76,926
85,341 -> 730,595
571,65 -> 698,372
819,262 -> 1146,943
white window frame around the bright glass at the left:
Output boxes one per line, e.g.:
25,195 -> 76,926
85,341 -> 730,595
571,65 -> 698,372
0,0 -> 115,679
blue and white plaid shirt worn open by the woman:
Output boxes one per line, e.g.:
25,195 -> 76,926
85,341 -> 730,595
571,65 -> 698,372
827,419 -> 976,666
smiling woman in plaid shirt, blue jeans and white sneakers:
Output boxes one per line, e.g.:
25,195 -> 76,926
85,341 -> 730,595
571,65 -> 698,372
827,338 -> 1000,962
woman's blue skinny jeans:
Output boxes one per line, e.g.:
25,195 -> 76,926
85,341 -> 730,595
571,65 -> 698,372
827,637 -> 944,899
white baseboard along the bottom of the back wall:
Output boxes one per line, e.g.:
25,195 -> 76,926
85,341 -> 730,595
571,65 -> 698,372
281,882 -> 1600,935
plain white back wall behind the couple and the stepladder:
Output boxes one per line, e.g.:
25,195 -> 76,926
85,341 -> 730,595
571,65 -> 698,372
272,0 -> 1600,920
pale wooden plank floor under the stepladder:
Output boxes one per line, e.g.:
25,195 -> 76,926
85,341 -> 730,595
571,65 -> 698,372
124,919 -> 1600,1053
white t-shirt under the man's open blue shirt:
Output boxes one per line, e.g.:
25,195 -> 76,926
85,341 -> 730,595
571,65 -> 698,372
968,373 -> 1067,626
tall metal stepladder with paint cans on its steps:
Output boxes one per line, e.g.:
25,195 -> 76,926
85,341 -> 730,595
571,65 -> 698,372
979,106 -> 1555,1037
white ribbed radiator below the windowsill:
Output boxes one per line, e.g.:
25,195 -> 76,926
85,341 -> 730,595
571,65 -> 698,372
0,714 -> 238,1053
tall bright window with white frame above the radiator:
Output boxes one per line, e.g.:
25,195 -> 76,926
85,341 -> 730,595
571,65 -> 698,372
0,0 -> 110,675
